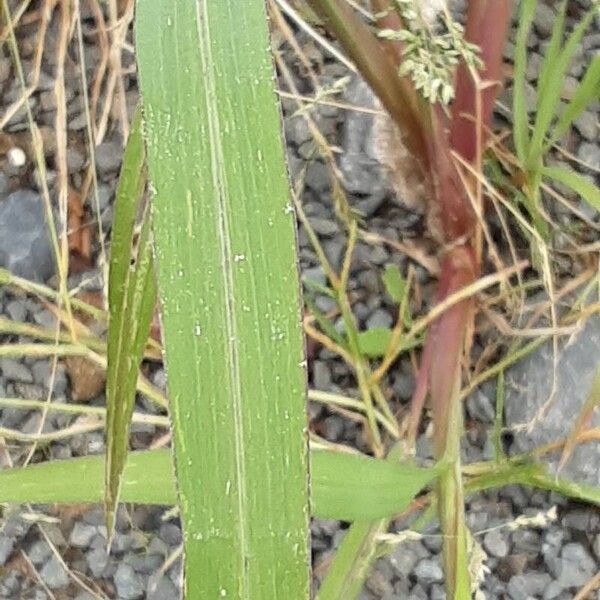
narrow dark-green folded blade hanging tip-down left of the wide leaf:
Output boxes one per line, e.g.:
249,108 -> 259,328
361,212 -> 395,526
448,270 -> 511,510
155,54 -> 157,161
104,112 -> 156,540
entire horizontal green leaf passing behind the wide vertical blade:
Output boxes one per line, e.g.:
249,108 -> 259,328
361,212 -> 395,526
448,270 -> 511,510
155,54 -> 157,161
0,450 -> 438,521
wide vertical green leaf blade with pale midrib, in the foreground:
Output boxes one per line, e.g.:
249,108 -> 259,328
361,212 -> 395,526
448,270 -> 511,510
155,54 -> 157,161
136,0 -> 310,600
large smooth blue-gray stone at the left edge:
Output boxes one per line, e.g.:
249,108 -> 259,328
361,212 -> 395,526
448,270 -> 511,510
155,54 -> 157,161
0,190 -> 54,281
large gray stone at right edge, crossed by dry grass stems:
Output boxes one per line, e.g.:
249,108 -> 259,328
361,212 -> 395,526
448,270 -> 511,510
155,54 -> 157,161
505,317 -> 600,485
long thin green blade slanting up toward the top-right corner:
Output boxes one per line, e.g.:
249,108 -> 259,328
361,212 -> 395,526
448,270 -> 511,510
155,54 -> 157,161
527,9 -> 594,167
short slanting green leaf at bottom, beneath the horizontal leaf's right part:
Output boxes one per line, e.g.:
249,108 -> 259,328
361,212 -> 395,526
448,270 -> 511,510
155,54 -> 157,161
317,519 -> 390,600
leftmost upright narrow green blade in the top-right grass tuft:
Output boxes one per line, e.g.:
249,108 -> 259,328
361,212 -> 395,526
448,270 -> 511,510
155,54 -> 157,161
513,0 -> 537,164
